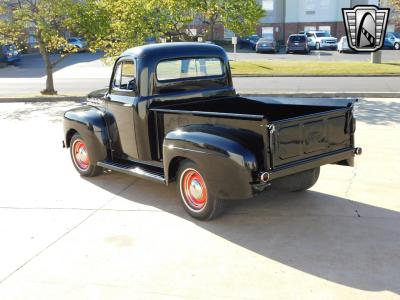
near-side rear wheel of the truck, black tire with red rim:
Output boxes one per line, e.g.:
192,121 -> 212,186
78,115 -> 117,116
177,160 -> 224,220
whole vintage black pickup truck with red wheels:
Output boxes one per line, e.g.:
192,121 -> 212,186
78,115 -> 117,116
63,43 -> 361,219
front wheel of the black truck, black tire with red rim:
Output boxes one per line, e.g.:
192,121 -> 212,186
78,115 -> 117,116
69,133 -> 103,177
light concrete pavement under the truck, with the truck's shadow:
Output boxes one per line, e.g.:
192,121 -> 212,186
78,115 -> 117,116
0,99 -> 400,300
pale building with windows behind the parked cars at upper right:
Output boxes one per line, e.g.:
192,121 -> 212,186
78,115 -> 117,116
219,0 -> 400,41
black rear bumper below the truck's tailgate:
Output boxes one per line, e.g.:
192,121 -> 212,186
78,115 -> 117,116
260,148 -> 362,182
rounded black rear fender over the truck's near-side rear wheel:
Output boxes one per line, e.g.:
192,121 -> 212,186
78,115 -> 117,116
163,125 -> 258,199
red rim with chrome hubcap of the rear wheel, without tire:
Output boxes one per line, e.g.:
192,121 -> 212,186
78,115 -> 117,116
180,169 -> 207,211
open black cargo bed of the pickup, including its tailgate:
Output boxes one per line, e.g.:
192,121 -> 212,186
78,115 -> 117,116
152,97 -> 356,171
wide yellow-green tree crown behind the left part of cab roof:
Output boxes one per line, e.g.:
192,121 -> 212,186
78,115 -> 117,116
86,0 -> 199,57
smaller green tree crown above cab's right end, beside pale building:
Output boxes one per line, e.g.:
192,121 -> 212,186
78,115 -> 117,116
195,0 -> 265,40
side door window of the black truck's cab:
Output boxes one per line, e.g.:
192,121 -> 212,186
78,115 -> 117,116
113,60 -> 136,91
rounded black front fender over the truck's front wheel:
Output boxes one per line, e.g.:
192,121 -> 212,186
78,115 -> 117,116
64,106 -> 108,164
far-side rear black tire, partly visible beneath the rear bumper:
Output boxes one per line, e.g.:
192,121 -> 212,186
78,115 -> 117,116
271,167 -> 320,192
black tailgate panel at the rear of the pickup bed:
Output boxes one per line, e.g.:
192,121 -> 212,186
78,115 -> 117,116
269,106 -> 355,169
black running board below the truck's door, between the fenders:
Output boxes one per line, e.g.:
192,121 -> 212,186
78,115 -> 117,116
97,160 -> 165,184
